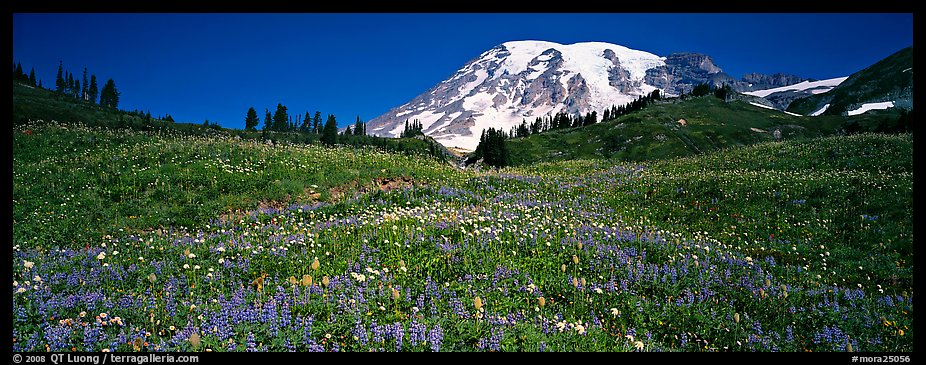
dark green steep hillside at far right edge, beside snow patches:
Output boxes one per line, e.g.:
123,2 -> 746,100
788,47 -> 913,115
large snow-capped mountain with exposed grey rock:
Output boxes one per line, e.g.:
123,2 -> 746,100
367,41 -> 800,150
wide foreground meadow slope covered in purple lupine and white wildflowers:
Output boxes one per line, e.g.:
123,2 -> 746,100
12,126 -> 915,352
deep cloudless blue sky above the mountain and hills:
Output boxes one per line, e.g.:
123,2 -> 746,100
13,14 -> 913,128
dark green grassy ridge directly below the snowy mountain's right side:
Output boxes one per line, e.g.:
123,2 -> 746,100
508,96 -> 844,165
